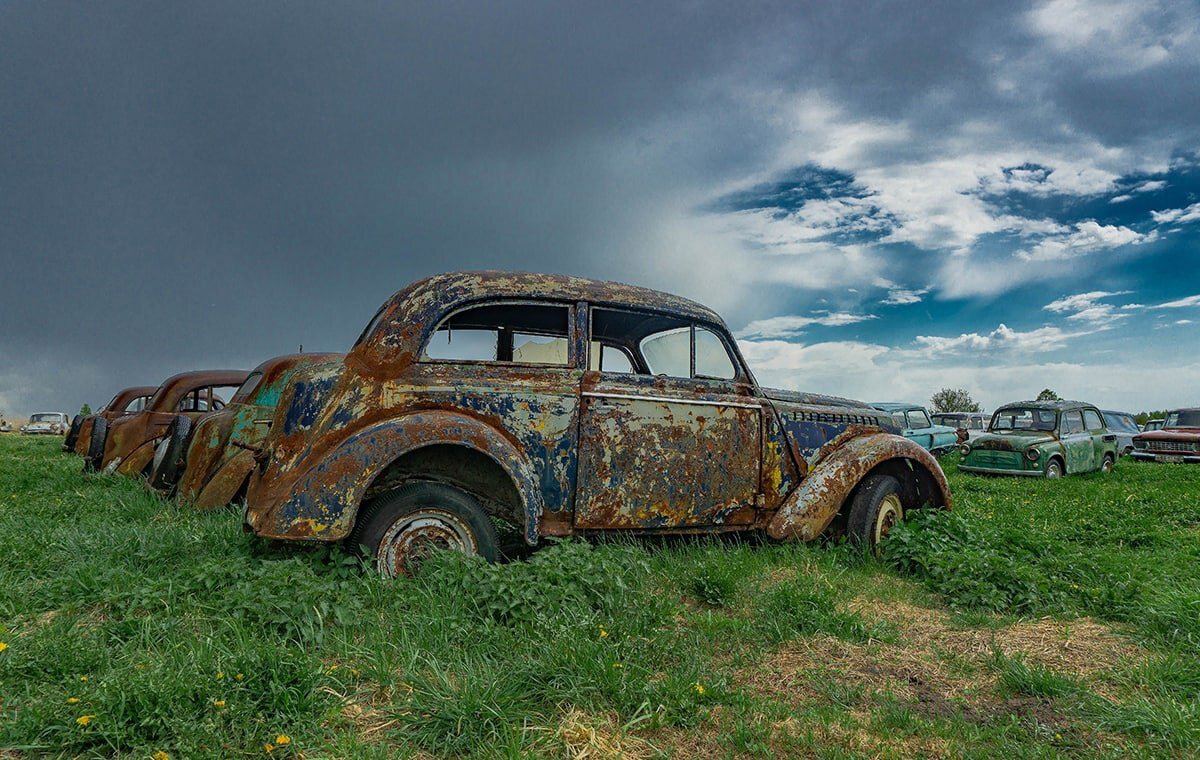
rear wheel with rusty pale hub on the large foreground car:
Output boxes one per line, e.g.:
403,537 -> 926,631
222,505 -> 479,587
347,481 -> 499,578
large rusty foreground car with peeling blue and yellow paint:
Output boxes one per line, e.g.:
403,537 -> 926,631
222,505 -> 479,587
245,273 -> 950,575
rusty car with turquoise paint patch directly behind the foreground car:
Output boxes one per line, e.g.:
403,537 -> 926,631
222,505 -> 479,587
150,353 -> 342,501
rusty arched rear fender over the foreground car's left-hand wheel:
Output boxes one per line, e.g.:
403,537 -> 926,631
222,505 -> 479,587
247,411 -> 544,544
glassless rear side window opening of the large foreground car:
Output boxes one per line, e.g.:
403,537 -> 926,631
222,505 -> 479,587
424,298 -> 570,366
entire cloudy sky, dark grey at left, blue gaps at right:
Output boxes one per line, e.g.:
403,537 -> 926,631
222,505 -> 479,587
0,0 -> 1200,414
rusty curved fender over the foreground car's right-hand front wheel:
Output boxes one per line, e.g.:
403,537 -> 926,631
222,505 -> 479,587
767,429 -> 950,540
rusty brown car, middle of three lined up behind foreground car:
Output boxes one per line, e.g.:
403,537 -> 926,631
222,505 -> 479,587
84,370 -> 250,475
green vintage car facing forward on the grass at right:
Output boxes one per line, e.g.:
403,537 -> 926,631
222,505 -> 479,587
959,401 -> 1117,478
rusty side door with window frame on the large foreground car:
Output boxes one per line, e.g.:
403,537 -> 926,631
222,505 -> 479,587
574,309 -> 763,529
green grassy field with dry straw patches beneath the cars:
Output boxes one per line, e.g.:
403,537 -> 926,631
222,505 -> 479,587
0,436 -> 1200,758
